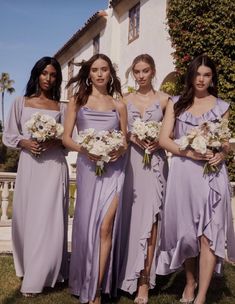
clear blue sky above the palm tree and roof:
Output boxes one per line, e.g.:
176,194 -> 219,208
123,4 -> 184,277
0,0 -> 109,119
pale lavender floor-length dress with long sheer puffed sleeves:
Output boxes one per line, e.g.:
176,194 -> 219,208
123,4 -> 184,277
3,97 -> 69,293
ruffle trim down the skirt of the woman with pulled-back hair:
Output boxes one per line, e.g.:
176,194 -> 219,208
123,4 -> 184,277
121,154 -> 164,294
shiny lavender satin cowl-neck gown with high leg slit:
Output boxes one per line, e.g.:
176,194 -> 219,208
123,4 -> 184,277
69,107 -> 125,303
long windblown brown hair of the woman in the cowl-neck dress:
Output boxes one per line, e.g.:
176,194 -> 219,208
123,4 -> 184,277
66,54 -> 122,106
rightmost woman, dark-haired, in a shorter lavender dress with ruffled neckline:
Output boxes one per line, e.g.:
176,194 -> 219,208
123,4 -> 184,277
157,55 -> 235,304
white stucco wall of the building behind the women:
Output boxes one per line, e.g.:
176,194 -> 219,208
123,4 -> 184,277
59,0 -> 174,174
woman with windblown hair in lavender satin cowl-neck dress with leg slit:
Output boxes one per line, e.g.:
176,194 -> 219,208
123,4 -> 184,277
63,54 -> 127,303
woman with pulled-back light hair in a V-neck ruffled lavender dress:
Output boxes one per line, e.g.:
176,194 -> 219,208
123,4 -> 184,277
119,54 -> 168,304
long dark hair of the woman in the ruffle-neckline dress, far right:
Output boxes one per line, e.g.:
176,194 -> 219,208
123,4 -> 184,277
174,54 -> 218,117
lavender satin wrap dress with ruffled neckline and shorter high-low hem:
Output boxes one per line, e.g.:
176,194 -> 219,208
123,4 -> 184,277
157,97 -> 235,274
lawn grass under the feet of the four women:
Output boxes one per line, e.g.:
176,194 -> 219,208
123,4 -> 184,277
0,254 -> 235,304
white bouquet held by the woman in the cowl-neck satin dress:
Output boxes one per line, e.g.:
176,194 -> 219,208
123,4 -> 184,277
77,128 -> 124,176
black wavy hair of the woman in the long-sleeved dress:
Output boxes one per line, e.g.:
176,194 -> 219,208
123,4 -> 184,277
24,56 -> 62,101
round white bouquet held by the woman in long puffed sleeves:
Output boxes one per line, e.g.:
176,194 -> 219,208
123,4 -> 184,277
25,112 -> 64,142
